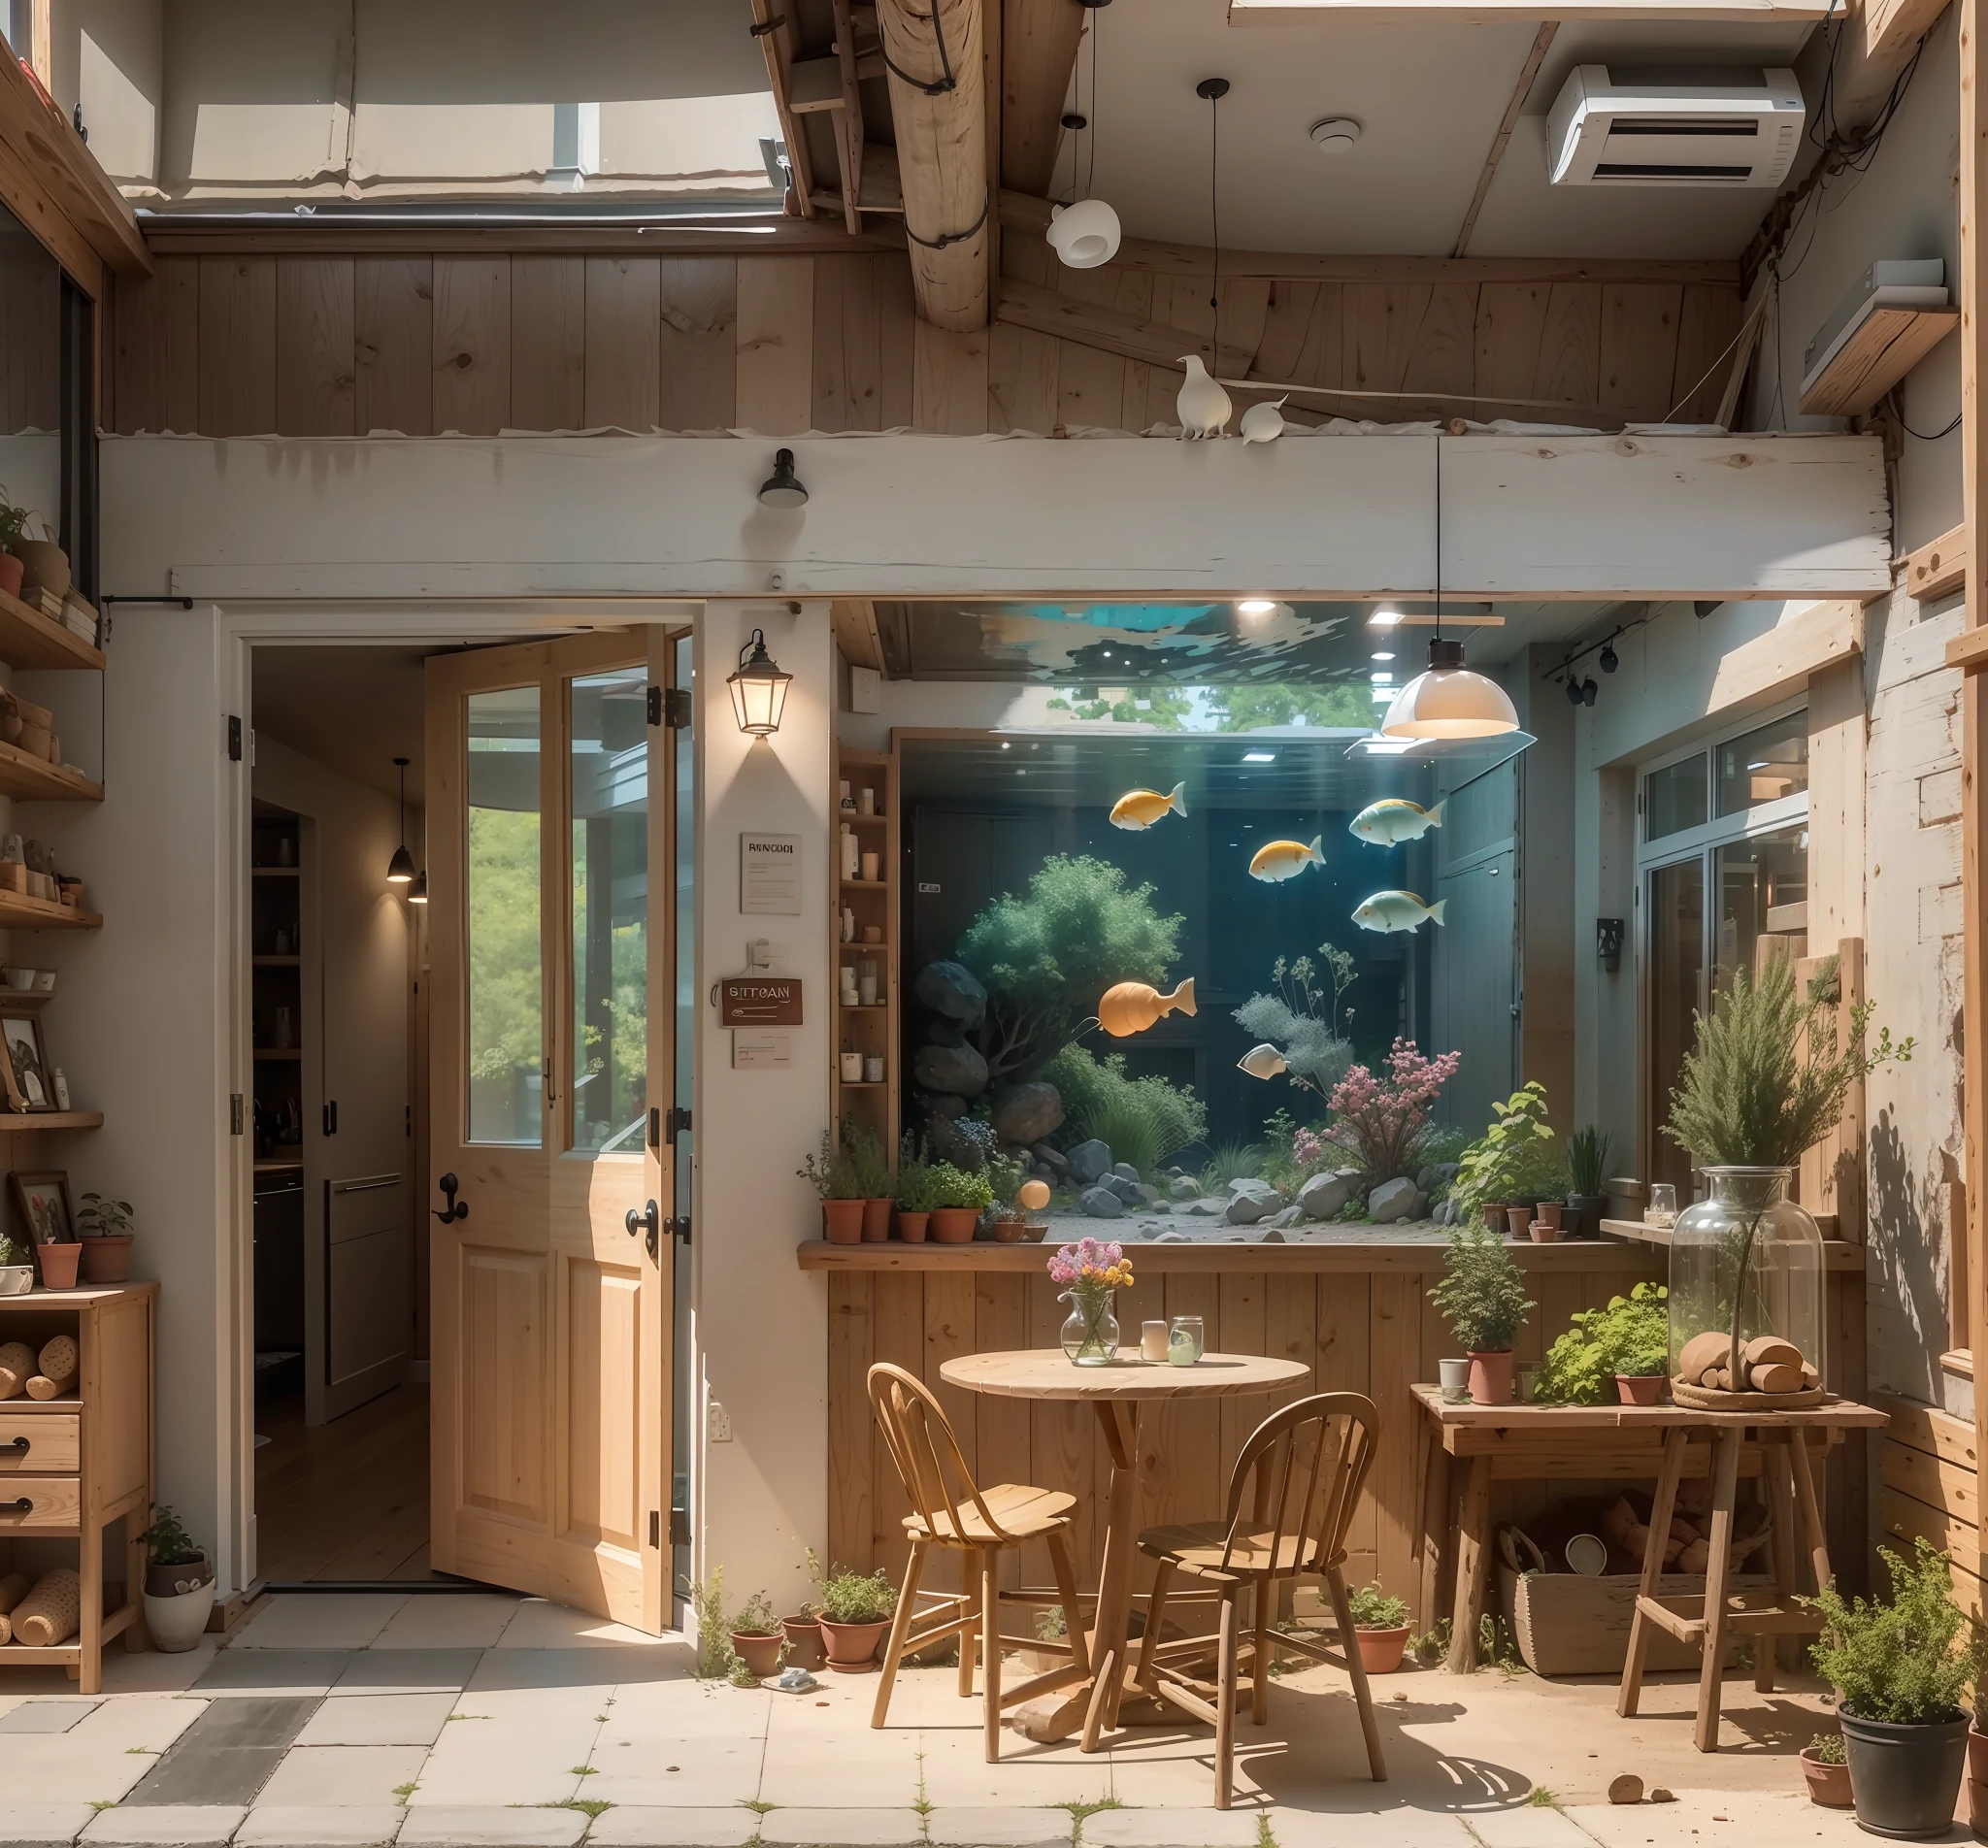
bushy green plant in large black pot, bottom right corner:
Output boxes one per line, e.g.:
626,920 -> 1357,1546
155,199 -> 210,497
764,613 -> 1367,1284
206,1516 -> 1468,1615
1804,1540 -> 1988,1836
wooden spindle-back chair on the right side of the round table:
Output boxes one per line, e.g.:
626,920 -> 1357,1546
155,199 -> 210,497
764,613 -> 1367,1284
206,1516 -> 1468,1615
1129,1393 -> 1388,1810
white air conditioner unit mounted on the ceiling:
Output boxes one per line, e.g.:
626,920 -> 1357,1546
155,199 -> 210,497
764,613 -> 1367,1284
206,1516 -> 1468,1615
1546,64 -> 1807,186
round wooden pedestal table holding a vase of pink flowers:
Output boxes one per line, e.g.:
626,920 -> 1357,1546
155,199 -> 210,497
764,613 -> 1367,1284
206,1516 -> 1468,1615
939,1347 -> 1312,1751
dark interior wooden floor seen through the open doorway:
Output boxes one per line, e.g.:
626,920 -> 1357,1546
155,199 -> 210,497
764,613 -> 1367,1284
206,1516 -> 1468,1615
254,1385 -> 429,1584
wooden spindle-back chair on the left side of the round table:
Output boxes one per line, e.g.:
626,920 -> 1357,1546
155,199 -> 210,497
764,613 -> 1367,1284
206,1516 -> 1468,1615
869,1361 -> 1089,1765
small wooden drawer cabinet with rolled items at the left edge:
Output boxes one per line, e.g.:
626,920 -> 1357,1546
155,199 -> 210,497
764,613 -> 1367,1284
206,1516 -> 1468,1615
0,1284 -> 159,1693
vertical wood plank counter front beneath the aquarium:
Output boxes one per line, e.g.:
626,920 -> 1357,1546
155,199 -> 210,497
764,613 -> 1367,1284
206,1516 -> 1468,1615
797,1234 -> 1666,1628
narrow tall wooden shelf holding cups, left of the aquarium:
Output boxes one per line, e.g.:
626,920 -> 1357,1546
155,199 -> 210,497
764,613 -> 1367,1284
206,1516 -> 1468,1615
829,747 -> 901,1167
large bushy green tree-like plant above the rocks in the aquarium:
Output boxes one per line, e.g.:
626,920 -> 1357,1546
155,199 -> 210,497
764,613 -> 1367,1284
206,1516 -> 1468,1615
958,854 -> 1183,1083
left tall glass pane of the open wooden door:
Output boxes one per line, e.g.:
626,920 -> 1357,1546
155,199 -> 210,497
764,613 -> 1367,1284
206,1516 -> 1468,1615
465,685 -> 545,1148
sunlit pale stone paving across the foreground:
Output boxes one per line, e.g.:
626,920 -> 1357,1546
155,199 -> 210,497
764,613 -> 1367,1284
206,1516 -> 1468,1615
0,1594 -> 1939,1848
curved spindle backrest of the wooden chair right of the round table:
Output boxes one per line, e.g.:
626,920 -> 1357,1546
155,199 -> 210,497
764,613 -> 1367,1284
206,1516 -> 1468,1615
1223,1393 -> 1379,1578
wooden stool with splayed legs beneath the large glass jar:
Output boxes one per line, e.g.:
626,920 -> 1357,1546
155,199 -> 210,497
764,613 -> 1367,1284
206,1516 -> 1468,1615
1616,1417 -> 1829,1753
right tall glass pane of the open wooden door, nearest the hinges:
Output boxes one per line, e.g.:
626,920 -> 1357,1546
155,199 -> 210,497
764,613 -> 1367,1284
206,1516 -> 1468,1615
571,668 -> 648,1154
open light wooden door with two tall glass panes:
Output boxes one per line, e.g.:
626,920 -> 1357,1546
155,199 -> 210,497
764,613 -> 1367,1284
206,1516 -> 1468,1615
427,626 -> 676,1632
